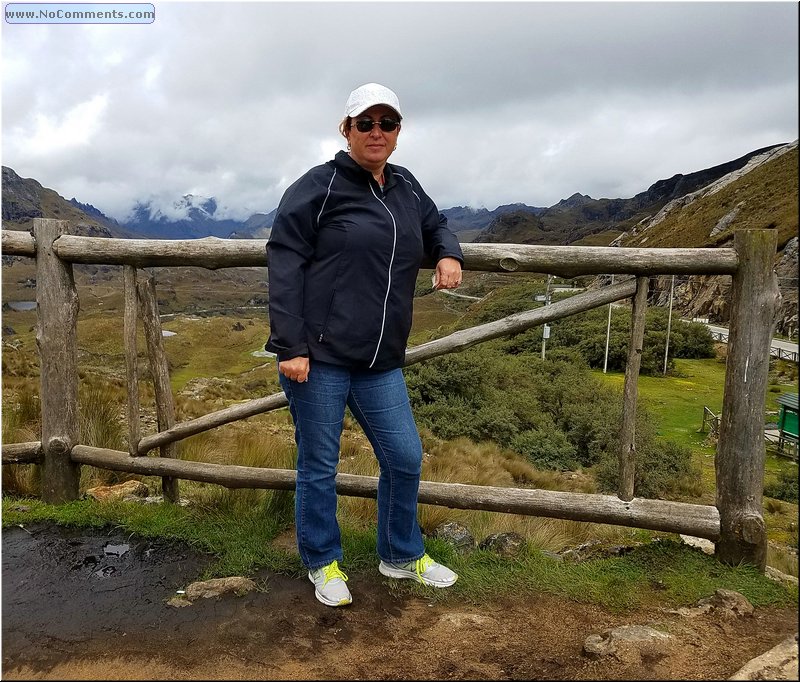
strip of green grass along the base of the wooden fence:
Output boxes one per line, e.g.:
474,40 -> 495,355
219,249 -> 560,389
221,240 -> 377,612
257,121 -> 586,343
3,491 -> 798,612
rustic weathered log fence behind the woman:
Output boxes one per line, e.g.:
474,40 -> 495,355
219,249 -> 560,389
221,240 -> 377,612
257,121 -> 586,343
2,219 -> 780,571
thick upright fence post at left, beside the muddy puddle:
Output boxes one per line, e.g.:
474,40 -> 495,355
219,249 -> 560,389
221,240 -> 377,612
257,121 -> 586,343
33,218 -> 80,504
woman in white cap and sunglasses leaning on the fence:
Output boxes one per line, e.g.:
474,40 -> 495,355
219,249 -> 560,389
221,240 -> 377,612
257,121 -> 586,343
266,83 -> 463,606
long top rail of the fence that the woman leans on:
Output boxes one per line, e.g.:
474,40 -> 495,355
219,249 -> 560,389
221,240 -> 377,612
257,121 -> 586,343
48,235 -> 738,277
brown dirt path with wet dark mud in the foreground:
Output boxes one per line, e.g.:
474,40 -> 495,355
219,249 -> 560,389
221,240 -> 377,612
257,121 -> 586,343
2,525 -> 797,680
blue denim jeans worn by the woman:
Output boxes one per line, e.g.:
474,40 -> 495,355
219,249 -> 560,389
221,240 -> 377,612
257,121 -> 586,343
279,358 -> 425,569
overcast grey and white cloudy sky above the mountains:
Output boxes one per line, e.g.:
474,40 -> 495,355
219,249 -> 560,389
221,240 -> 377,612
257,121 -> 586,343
2,0 -> 798,220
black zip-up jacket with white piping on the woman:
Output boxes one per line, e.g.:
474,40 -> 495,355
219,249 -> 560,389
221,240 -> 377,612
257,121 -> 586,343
265,151 -> 463,370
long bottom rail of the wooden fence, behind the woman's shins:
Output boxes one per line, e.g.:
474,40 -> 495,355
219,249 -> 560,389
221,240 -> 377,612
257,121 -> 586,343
72,445 -> 719,540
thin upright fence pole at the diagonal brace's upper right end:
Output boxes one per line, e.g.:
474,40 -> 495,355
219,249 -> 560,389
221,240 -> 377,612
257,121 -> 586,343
618,277 -> 649,500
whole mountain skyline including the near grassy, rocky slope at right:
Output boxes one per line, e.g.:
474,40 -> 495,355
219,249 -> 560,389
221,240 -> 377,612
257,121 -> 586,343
2,140 -> 798,336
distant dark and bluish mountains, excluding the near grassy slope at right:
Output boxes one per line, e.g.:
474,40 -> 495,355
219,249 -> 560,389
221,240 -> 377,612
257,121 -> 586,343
2,145 -> 781,244
